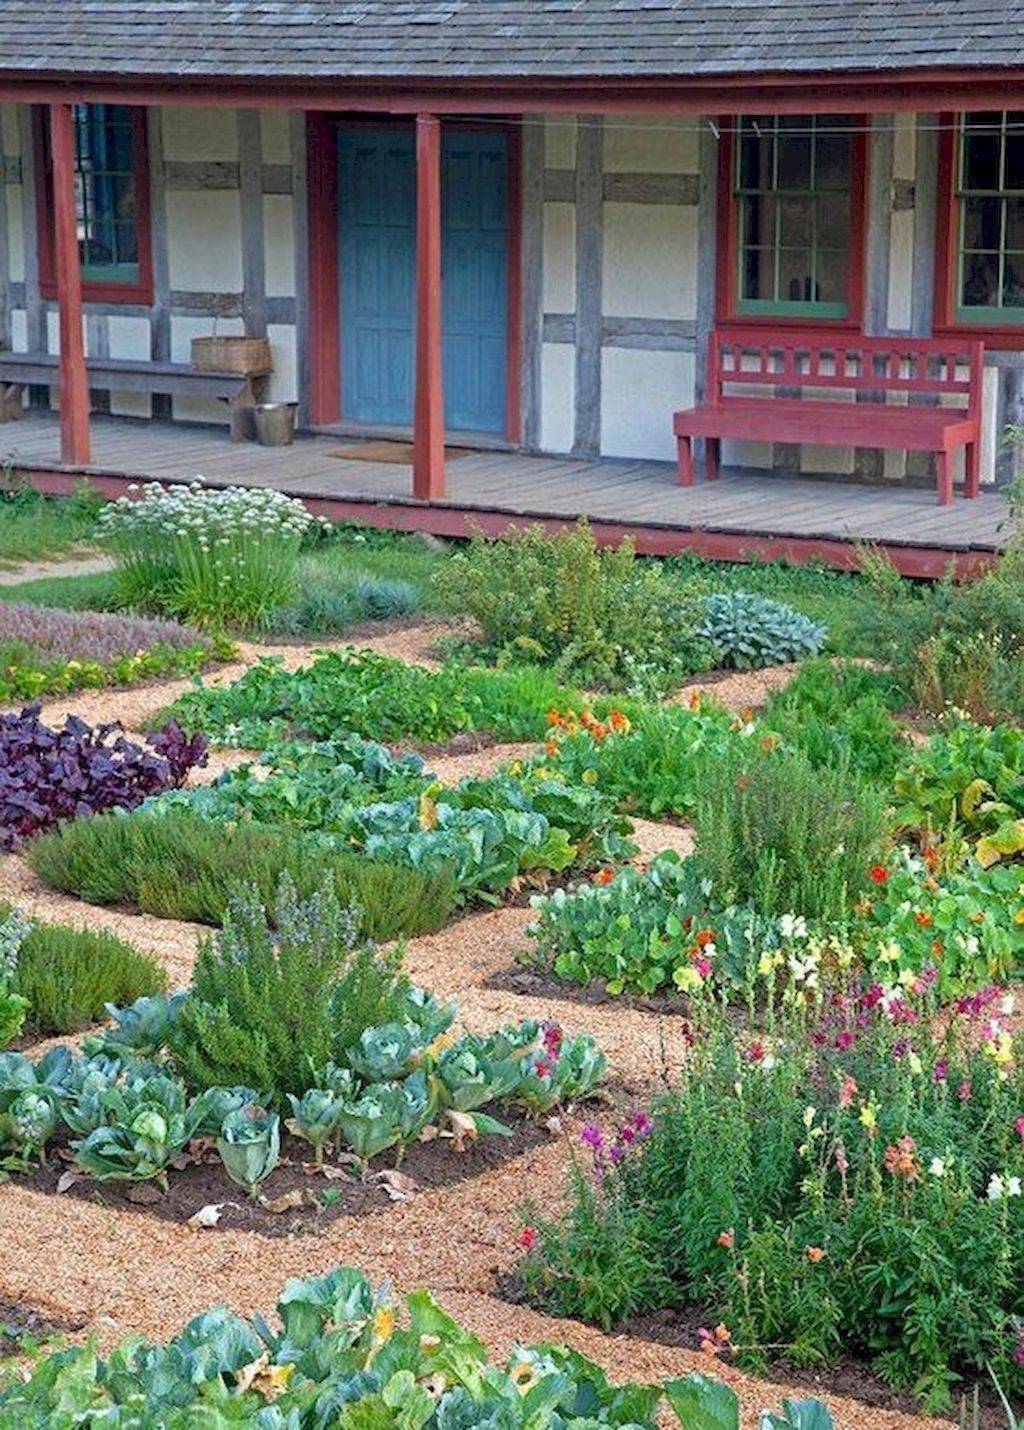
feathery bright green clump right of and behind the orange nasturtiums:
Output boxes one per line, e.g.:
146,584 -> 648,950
764,659 -> 908,784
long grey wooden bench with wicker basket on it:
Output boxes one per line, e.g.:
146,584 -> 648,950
0,353 -> 269,442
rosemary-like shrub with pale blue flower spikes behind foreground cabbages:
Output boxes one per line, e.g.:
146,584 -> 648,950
172,875 -> 408,1100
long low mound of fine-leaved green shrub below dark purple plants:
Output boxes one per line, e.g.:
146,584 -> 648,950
27,811 -> 455,940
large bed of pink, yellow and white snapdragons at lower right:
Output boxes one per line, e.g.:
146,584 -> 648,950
521,985 -> 1024,1409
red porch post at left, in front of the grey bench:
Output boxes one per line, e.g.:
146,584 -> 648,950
50,103 -> 89,466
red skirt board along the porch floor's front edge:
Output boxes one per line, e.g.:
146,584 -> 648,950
19,465 -> 998,581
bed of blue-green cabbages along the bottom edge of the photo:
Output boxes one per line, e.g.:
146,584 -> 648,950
0,1267 -> 832,1430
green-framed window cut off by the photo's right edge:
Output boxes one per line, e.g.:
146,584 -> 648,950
955,110 -> 1024,326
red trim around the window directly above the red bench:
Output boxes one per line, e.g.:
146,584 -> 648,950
715,114 -> 870,332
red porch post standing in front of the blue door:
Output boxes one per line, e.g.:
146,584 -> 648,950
412,114 -> 445,502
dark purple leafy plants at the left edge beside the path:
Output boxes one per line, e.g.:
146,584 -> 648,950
0,705 -> 206,849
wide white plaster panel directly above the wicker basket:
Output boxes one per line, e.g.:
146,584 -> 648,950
167,190 -> 242,293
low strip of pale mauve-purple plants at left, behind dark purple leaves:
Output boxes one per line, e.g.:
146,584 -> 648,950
0,602 -> 206,665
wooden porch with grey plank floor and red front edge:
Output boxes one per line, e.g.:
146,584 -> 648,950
0,410 -> 1008,576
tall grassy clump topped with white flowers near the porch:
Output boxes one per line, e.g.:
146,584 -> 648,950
97,480 -> 315,629
